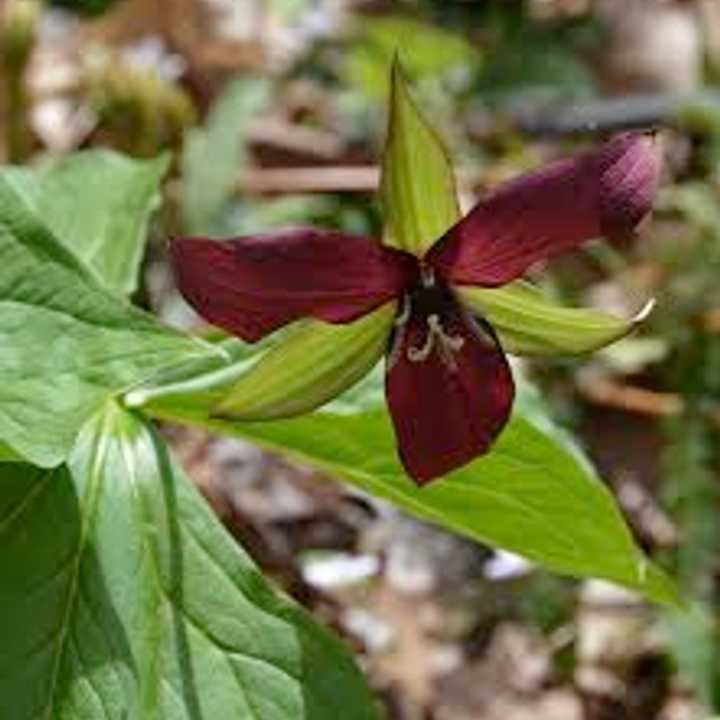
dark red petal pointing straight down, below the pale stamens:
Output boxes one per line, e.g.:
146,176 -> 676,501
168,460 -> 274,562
385,298 -> 514,485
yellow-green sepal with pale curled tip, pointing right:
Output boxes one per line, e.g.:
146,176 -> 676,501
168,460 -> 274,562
456,280 -> 652,355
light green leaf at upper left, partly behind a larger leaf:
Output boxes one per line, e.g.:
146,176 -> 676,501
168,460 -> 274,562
0,150 -> 168,294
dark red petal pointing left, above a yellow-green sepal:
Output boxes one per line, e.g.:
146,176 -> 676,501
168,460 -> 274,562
170,228 -> 417,342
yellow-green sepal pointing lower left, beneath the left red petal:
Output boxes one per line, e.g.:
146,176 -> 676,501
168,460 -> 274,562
212,302 -> 397,420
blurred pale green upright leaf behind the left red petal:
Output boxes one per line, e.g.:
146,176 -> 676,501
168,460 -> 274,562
182,78 -> 270,234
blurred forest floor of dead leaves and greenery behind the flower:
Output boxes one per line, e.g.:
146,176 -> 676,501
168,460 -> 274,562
0,0 -> 720,720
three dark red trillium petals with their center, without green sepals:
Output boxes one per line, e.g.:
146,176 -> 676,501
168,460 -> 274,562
171,133 -> 660,484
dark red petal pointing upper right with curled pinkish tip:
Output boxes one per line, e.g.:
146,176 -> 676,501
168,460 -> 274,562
427,133 -> 660,287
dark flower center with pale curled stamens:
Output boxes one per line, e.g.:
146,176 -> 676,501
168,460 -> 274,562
393,268 -> 465,372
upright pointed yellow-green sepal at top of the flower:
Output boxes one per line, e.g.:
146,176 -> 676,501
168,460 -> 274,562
380,60 -> 460,255
